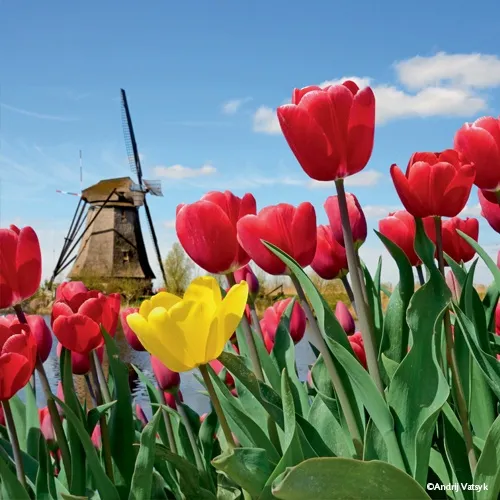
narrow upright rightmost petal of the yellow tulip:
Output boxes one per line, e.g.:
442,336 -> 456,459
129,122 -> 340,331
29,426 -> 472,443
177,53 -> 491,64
205,281 -> 248,360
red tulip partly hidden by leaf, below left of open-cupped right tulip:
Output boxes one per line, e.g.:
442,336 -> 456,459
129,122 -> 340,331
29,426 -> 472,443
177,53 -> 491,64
378,210 -> 421,266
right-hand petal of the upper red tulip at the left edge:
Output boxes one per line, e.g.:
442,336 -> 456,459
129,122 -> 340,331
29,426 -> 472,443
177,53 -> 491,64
15,227 -> 42,299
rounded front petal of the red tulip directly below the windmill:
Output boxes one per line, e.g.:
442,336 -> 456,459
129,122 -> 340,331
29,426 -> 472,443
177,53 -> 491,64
52,314 -> 103,354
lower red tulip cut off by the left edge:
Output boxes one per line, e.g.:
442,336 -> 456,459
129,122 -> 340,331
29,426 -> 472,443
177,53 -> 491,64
0,322 -> 37,401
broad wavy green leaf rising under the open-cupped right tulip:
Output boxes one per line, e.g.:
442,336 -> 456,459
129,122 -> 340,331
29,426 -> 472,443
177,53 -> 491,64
387,219 -> 451,484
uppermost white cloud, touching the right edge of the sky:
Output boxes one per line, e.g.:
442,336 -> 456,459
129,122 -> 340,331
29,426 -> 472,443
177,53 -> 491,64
394,52 -> 500,89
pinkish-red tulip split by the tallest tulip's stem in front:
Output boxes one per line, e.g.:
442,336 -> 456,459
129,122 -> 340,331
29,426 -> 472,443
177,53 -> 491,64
323,193 -> 368,249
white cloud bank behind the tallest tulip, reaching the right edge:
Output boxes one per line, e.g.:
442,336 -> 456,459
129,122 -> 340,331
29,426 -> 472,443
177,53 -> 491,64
253,52 -> 500,135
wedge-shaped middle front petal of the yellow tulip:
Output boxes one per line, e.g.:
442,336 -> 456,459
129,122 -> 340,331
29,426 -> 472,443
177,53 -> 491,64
169,300 -> 214,364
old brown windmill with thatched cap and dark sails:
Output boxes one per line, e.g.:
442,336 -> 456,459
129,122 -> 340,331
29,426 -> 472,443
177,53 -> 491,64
50,89 -> 166,293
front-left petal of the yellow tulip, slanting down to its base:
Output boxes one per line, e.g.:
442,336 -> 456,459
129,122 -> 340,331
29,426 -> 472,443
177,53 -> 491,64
145,307 -> 196,371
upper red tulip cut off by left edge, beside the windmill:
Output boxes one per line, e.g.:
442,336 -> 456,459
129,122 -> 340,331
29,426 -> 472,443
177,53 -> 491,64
0,226 -> 42,309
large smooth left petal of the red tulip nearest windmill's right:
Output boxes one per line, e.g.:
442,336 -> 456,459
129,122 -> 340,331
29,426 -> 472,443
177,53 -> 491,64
175,201 -> 238,274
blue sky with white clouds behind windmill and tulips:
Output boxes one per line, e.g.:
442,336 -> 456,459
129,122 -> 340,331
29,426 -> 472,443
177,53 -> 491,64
0,0 -> 500,281
